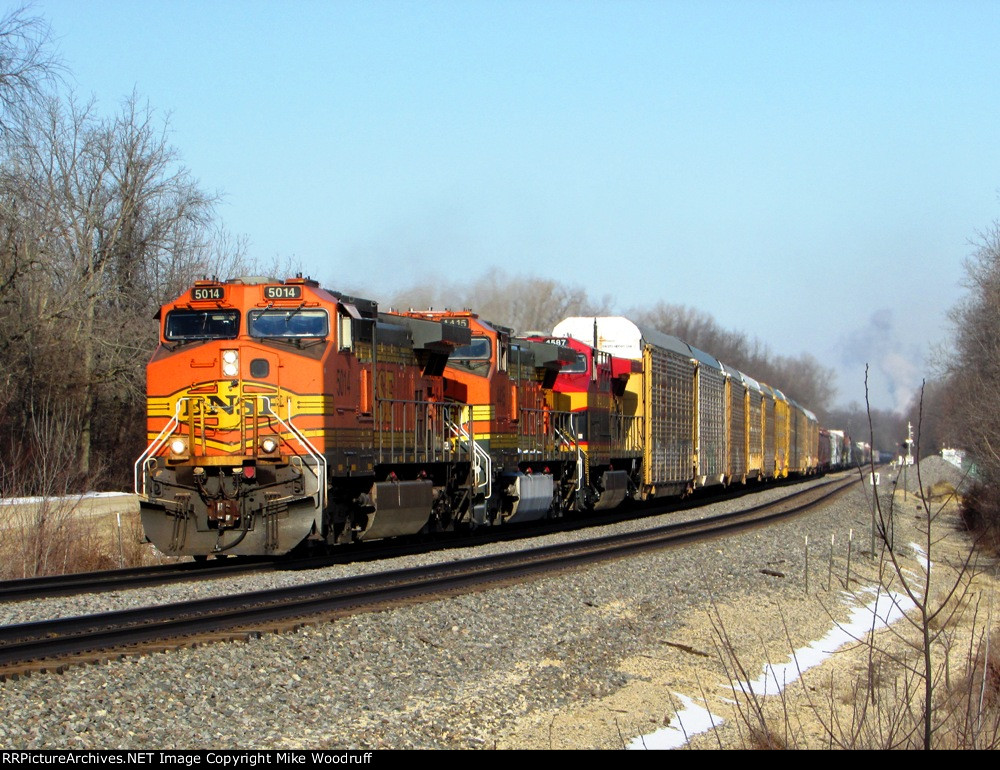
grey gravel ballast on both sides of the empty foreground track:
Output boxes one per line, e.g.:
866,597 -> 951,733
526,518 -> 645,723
0,464 -> 976,749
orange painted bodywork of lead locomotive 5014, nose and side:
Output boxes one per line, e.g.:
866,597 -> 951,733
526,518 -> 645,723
147,279 -> 444,464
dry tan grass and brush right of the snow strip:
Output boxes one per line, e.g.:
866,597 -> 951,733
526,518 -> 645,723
716,480 -> 1000,749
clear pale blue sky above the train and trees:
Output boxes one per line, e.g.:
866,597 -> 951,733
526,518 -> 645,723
33,0 -> 1000,408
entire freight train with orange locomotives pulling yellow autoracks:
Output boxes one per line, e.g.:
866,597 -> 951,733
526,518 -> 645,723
135,277 -> 828,558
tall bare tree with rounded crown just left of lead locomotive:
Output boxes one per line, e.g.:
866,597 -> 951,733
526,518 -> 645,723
0,90 -> 232,478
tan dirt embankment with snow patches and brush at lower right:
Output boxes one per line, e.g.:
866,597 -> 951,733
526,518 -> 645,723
498,458 -> 1000,748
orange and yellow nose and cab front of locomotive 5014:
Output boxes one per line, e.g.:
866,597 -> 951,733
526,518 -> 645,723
147,282 -> 334,463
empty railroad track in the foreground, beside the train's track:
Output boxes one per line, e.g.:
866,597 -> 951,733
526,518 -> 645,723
0,478 -> 857,679
